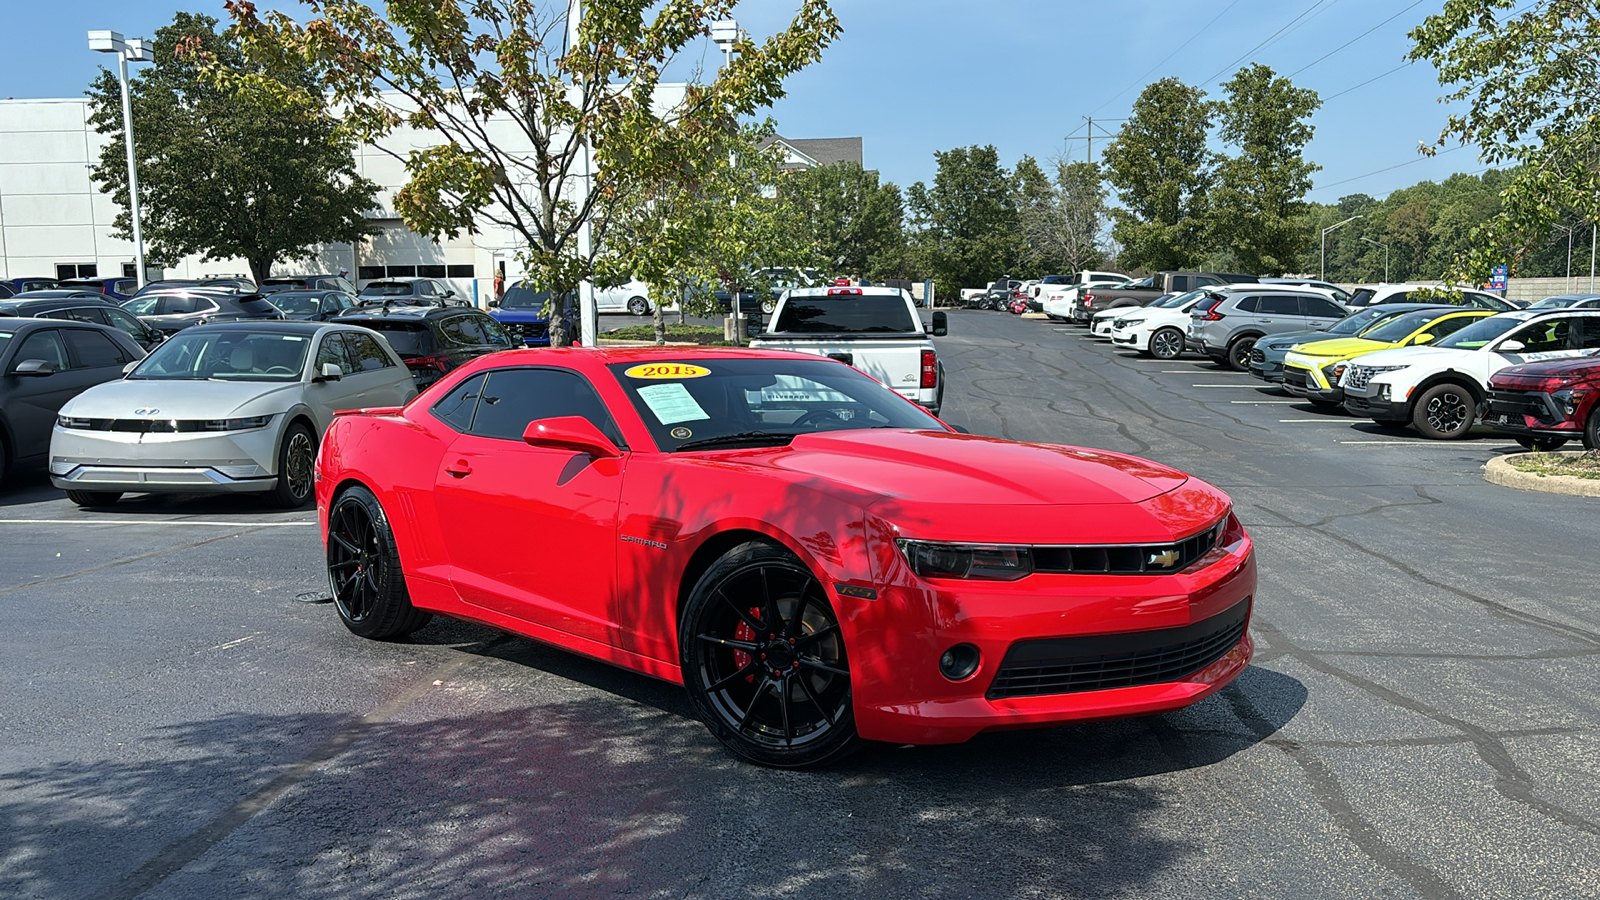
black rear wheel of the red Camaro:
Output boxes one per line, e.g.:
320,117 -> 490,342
326,485 -> 434,641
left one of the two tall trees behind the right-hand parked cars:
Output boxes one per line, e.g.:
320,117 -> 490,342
1106,78 -> 1216,269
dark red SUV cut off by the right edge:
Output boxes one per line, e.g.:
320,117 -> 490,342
1483,356 -> 1600,450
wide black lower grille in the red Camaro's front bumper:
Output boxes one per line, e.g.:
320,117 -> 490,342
989,597 -> 1250,700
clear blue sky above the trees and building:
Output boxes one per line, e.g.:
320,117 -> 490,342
0,0 -> 1483,202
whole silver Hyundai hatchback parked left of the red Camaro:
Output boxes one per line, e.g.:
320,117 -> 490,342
50,322 -> 416,508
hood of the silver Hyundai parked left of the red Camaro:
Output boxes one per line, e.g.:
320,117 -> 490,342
61,380 -> 302,420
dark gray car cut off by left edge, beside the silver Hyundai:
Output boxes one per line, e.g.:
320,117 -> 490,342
0,319 -> 144,479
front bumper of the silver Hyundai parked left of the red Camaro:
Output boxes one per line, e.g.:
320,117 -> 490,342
50,416 -> 283,493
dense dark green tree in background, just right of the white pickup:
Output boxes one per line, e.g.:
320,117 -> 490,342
906,144 -> 1019,296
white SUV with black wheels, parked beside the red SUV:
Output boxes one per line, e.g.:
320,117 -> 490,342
1339,309 -> 1600,439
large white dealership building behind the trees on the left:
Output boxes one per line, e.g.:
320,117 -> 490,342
0,94 -> 861,299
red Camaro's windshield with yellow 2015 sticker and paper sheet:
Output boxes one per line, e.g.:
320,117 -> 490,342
610,357 -> 946,453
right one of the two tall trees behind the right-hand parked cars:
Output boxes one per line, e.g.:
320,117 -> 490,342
1208,64 -> 1322,275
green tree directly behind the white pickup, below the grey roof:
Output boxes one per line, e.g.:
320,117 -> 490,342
778,162 -> 906,279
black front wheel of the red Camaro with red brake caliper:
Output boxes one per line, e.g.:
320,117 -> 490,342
678,541 -> 861,769
